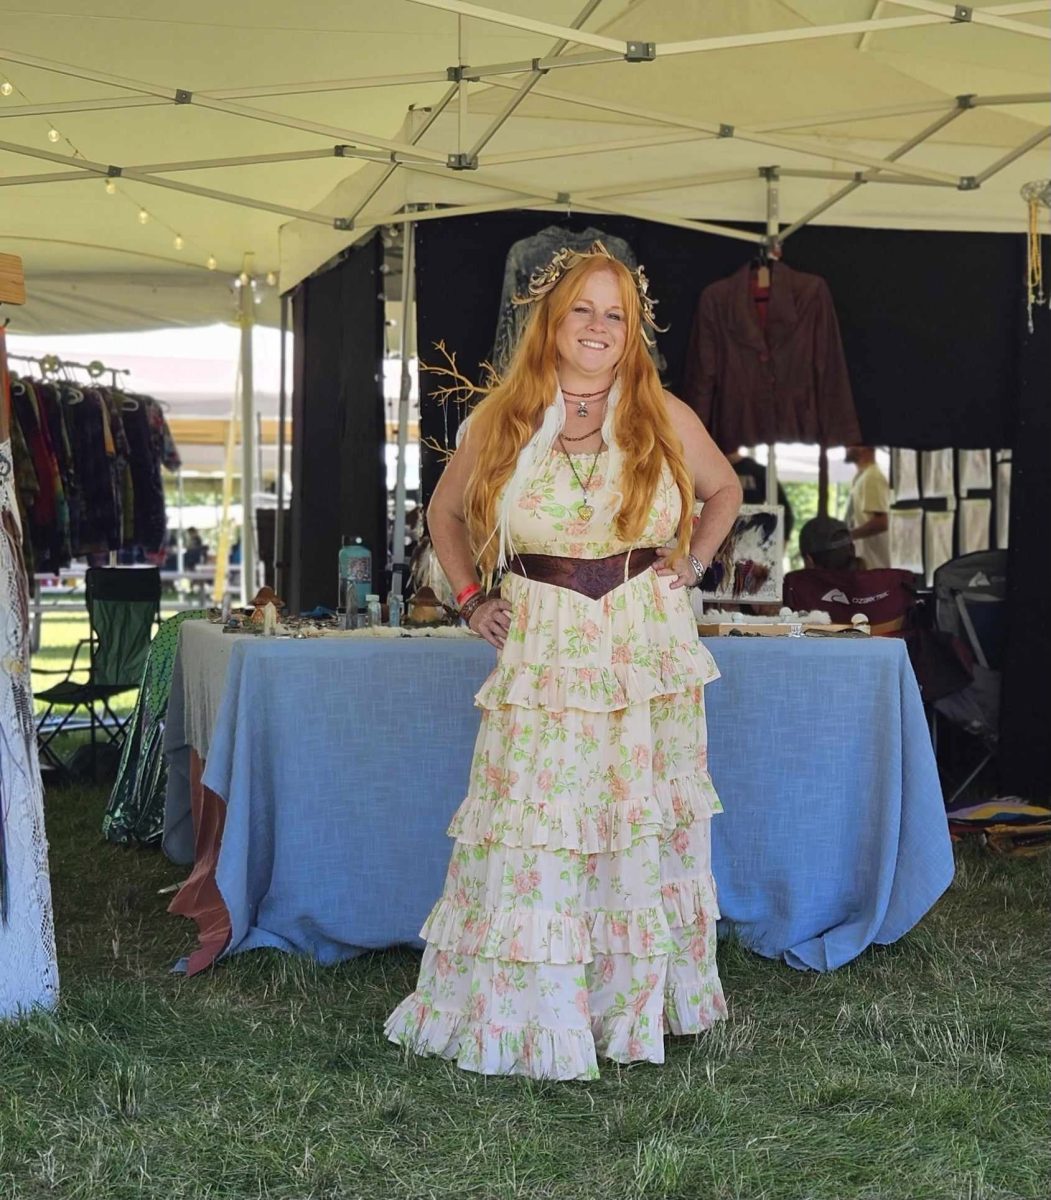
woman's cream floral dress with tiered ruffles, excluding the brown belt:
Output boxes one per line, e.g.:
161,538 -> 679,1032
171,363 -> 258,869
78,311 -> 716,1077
386,452 -> 726,1079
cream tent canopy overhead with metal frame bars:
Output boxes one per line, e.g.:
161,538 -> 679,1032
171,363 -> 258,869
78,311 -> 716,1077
0,0 -> 1051,334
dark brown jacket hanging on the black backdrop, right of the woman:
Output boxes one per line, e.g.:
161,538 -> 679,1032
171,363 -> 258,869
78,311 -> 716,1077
683,262 -> 861,451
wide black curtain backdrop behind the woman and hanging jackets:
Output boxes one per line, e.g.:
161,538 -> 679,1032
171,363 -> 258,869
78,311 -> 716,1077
416,210 -> 1051,796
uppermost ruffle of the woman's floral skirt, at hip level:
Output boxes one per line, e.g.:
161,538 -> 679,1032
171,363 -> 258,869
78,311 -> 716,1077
474,642 -> 719,713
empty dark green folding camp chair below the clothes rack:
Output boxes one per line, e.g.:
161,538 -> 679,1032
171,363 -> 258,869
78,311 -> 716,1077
37,566 -> 161,772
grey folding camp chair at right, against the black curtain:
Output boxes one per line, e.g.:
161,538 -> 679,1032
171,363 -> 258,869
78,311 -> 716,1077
933,550 -> 1007,806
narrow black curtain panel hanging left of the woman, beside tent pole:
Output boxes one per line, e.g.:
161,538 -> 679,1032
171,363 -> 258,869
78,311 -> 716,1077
284,235 -> 386,612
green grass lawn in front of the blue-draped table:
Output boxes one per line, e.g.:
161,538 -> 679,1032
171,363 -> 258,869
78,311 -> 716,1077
0,624 -> 1051,1200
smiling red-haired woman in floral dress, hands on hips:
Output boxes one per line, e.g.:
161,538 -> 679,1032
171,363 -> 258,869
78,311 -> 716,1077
386,242 -> 740,1079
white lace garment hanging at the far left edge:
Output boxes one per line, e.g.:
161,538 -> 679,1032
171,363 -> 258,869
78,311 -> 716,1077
0,440 -> 59,1020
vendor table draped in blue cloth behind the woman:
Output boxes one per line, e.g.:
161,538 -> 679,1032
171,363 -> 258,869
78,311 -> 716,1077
164,622 -> 953,972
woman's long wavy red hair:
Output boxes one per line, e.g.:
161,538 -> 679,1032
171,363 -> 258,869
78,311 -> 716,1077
464,253 -> 693,577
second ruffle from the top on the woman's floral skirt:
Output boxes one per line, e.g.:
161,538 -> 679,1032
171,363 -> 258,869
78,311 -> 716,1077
449,772 -> 722,854
